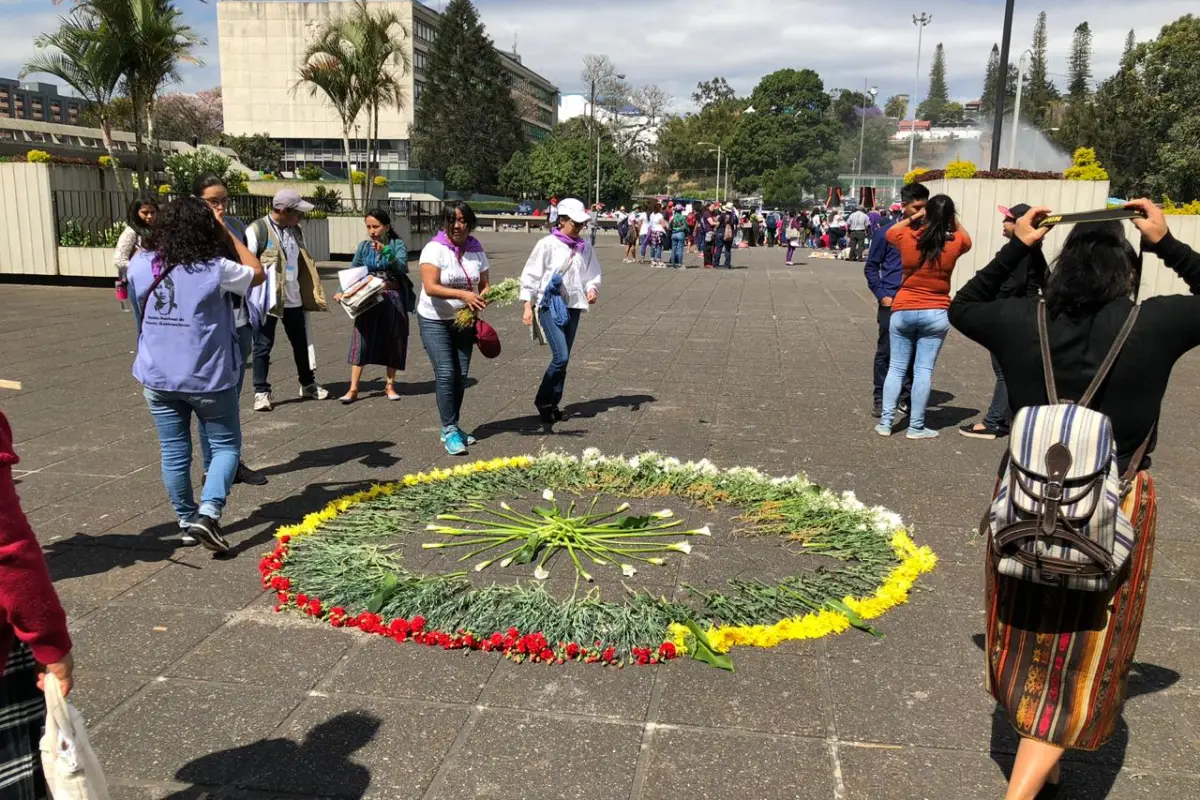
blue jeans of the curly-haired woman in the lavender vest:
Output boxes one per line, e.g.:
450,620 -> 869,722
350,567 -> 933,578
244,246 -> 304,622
143,389 -> 241,524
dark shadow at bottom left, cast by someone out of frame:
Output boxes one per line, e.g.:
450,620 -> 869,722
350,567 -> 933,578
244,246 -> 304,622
159,711 -> 383,800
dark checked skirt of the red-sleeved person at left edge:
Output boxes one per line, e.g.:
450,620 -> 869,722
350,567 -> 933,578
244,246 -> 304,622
0,640 -> 47,800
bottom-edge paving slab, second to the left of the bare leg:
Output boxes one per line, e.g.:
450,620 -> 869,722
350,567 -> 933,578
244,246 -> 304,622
637,728 -> 835,800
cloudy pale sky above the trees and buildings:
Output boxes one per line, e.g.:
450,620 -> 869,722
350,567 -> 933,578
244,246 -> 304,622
0,0 -> 1196,110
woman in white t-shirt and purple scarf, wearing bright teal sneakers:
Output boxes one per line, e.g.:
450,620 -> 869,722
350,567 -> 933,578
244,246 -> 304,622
416,201 -> 488,456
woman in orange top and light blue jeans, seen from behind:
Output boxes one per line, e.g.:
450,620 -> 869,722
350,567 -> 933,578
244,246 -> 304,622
875,194 -> 971,439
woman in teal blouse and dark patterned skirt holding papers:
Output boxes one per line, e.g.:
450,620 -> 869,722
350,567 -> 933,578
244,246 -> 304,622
334,209 -> 415,405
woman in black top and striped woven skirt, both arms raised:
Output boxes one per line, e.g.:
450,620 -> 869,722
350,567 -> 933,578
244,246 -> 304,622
949,200 -> 1200,800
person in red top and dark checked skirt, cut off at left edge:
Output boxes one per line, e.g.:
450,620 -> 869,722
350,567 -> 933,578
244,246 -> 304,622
0,414 -> 74,800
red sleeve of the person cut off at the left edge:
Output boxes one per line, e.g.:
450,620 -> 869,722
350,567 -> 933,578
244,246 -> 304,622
0,414 -> 71,664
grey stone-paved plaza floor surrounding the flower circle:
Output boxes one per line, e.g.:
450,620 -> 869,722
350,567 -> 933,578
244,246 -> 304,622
0,233 -> 1200,800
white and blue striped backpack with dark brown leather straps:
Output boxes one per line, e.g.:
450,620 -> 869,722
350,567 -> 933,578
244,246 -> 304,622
983,301 -> 1153,591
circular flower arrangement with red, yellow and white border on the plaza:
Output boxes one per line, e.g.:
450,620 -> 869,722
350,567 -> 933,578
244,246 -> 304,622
259,450 -> 937,668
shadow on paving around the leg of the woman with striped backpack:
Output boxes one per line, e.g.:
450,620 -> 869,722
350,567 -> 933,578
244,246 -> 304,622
972,633 -> 1180,800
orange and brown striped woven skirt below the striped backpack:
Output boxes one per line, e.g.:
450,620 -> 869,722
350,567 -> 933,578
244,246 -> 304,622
986,473 -> 1157,750
